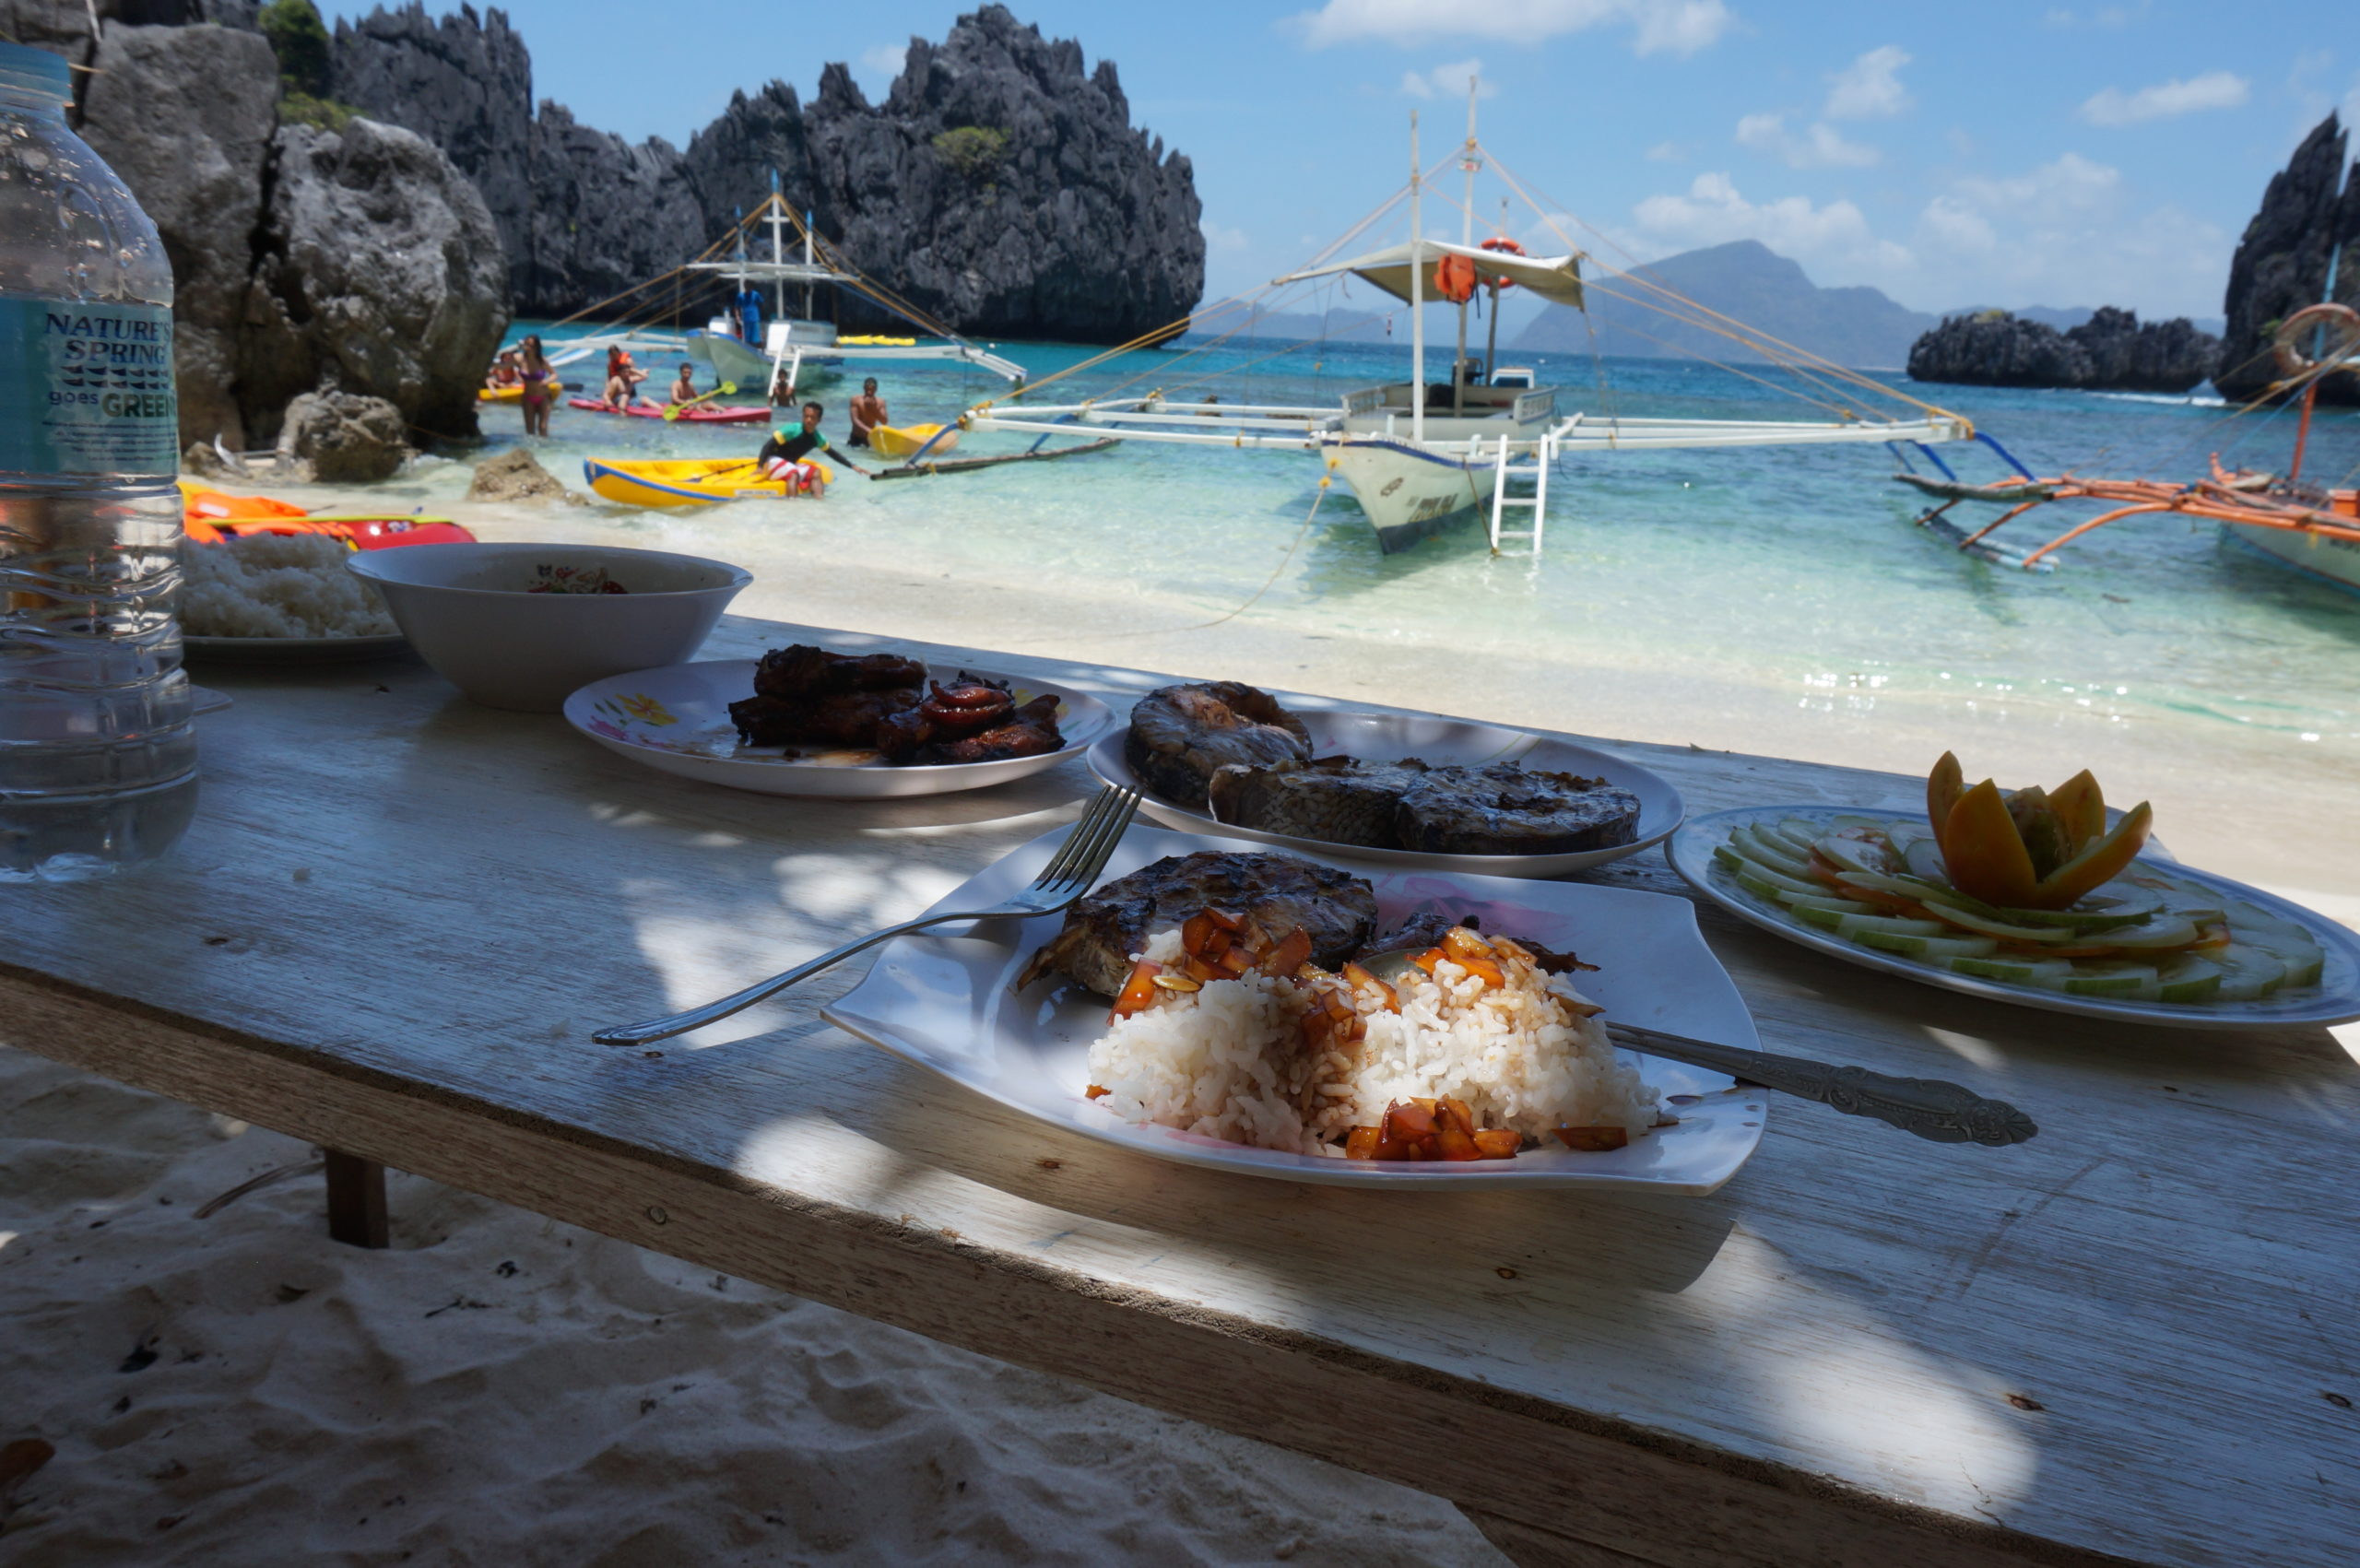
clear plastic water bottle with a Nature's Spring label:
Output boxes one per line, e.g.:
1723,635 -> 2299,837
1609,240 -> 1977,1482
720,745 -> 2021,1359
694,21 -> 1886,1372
0,42 -> 195,881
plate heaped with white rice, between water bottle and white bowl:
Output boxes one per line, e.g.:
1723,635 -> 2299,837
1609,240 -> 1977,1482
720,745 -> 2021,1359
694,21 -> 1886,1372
180,534 -> 408,664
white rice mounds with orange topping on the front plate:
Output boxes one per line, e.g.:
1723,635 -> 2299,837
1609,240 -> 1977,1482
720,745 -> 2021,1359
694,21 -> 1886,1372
1091,930 -> 1657,1155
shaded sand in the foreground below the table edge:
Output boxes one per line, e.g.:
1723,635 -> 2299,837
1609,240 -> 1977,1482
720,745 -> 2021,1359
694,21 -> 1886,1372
0,1051 -> 1504,1568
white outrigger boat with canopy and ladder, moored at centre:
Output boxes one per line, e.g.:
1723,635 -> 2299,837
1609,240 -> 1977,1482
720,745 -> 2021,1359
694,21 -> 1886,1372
961,83 -> 1976,555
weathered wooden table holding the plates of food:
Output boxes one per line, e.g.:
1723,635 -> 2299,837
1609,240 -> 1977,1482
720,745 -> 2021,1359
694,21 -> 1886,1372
0,621 -> 2360,1568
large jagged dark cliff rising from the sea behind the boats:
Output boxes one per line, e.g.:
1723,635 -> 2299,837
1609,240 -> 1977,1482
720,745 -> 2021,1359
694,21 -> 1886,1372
336,0 -> 1204,340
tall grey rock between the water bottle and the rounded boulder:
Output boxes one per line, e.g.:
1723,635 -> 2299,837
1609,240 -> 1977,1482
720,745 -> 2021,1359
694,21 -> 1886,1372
83,26 -> 278,449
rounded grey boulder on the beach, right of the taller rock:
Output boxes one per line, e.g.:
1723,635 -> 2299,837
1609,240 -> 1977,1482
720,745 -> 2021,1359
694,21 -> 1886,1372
239,121 -> 507,437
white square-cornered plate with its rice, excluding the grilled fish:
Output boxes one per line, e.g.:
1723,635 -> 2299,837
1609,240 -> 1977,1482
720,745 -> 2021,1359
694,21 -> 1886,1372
821,827 -> 1767,1197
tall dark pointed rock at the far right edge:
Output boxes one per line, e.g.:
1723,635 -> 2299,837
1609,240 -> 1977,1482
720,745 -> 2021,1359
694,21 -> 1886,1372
2213,113 -> 2360,404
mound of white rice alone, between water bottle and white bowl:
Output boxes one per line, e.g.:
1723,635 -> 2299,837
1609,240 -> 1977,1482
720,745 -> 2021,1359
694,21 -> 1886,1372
180,534 -> 396,638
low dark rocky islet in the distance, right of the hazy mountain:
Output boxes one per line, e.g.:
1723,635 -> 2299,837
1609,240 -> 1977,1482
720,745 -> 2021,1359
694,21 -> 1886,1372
1909,304 -> 2221,392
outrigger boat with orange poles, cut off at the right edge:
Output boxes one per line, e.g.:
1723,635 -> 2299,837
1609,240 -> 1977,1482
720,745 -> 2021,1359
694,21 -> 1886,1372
1893,304 -> 2360,593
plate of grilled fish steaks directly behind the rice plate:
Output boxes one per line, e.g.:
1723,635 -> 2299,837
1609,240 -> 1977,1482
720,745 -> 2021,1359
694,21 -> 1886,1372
1091,680 -> 1687,876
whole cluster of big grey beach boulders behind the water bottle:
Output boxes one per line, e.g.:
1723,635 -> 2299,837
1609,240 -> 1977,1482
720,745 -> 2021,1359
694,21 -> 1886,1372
0,0 -> 507,446
